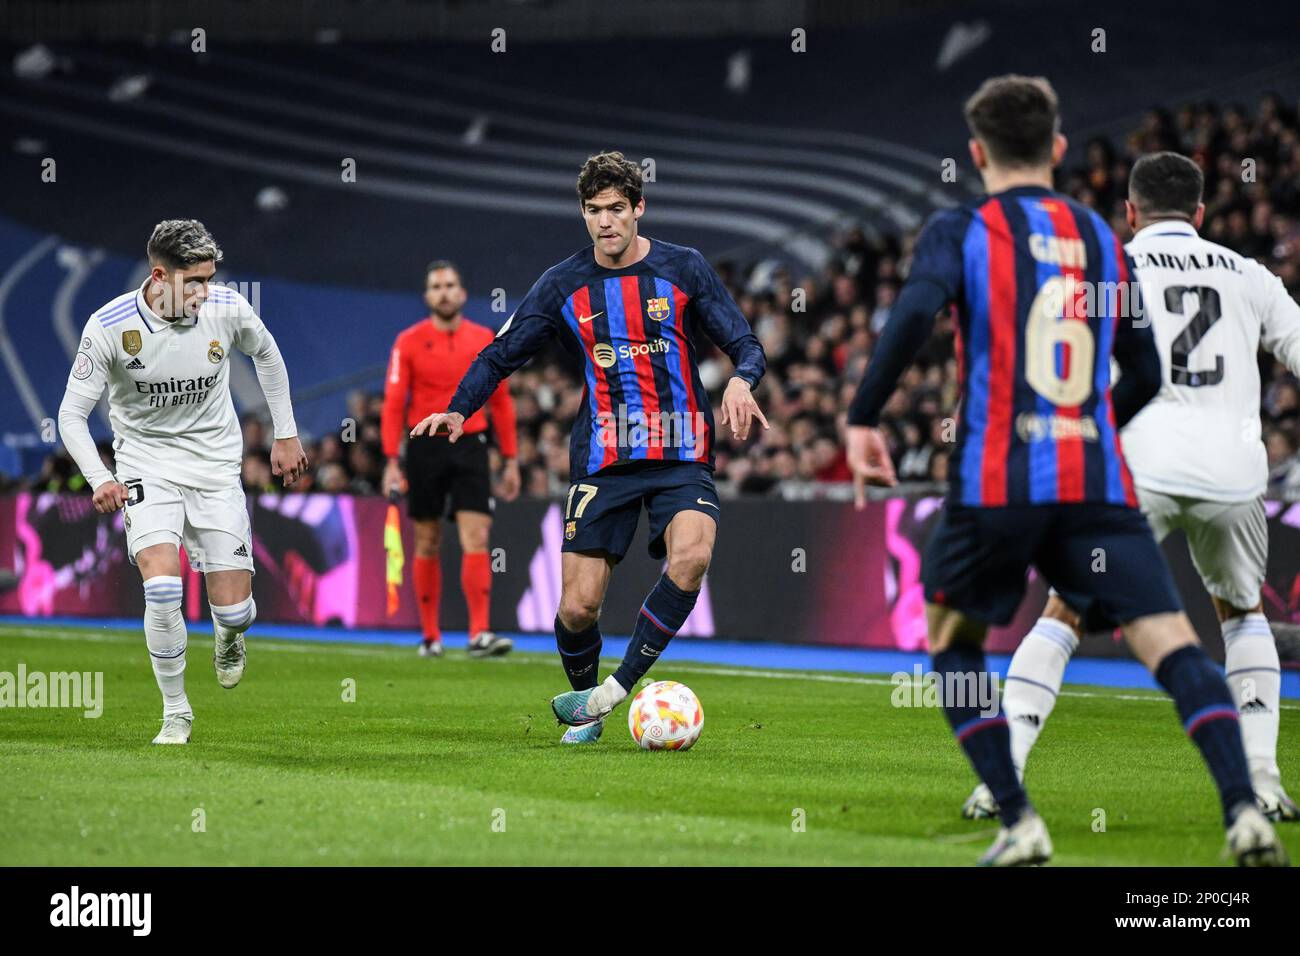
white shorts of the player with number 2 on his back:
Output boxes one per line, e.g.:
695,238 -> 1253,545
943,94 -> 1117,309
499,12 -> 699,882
1138,488 -> 1269,610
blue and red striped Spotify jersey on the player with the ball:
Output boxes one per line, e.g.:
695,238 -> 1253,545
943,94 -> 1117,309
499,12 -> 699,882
449,239 -> 767,481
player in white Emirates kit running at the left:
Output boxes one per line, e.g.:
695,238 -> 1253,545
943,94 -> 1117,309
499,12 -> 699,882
59,220 -> 307,744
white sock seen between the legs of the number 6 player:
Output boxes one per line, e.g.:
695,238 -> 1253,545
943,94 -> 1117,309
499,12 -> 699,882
1002,618 -> 1079,780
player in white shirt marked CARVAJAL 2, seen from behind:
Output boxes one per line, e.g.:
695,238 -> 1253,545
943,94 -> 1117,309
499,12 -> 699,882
962,152 -> 1300,821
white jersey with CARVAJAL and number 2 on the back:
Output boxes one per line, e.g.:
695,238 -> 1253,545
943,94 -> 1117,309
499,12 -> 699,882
1122,221 -> 1300,501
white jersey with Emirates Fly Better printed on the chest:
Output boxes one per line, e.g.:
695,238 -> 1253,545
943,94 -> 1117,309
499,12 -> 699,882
68,285 -> 273,490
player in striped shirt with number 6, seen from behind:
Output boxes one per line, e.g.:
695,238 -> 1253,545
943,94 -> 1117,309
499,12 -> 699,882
849,75 -> 1286,865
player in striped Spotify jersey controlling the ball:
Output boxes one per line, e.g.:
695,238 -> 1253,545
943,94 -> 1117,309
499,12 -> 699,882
411,152 -> 767,744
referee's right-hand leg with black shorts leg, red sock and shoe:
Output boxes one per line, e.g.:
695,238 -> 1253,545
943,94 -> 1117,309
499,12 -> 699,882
450,434 -> 515,657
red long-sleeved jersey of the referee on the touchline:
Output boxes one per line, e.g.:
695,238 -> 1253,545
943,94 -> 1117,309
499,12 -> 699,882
384,319 -> 516,458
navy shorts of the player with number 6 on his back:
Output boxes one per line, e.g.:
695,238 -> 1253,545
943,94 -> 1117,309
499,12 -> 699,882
920,503 -> 1183,631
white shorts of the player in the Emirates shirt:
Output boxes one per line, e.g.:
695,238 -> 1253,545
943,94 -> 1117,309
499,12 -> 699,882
118,475 -> 252,571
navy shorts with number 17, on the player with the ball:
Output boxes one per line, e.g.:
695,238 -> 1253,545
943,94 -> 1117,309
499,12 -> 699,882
560,462 -> 720,561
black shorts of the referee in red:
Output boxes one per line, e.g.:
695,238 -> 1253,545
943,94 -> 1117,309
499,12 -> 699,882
404,432 -> 495,522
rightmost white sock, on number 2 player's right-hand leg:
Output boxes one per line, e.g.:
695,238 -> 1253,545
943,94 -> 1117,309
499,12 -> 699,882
1223,613 -> 1282,790
